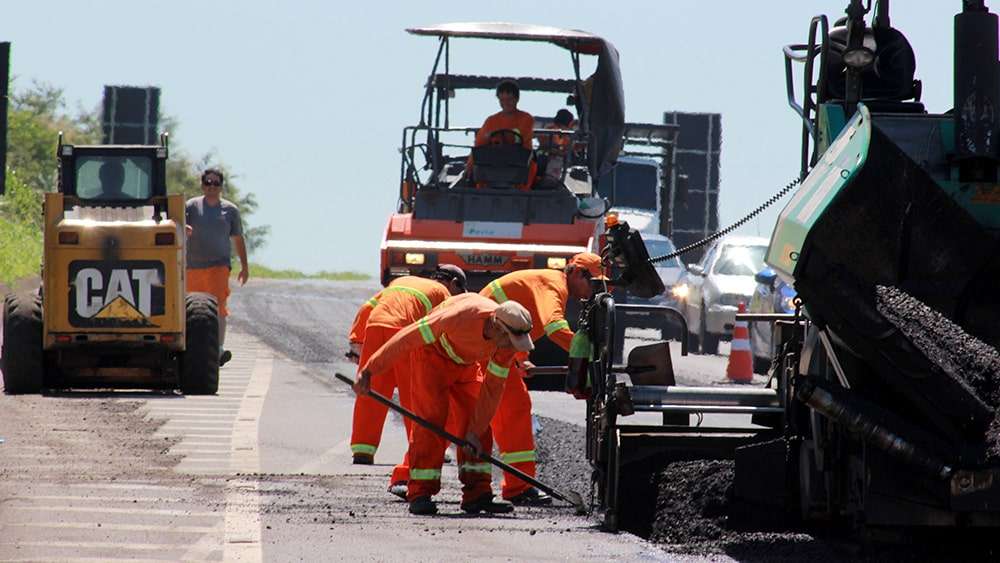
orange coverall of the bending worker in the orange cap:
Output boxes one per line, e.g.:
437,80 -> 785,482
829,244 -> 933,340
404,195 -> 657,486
480,270 -> 573,499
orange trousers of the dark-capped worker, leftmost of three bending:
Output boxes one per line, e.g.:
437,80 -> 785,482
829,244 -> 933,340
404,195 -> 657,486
351,326 -> 411,484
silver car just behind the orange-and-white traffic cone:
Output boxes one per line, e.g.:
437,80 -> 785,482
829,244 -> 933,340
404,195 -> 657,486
672,236 -> 768,354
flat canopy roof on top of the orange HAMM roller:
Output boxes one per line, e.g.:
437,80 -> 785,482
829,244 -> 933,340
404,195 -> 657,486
406,22 -> 604,55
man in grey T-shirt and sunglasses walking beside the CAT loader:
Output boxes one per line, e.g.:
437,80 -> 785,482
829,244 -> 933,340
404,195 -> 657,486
185,168 -> 250,366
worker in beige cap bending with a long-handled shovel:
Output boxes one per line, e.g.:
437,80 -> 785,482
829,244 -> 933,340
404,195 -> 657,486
355,293 -> 533,514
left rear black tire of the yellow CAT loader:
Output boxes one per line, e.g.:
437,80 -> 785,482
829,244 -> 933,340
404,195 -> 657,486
0,293 -> 45,395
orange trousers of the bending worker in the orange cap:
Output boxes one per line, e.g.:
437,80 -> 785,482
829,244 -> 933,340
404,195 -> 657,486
491,364 -> 536,499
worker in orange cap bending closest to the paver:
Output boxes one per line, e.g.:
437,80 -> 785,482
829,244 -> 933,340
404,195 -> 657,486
480,252 -> 606,505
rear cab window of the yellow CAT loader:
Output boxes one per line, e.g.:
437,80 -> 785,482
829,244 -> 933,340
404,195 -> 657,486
76,156 -> 153,201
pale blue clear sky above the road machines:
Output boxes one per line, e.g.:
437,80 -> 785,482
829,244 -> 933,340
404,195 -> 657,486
0,0 -> 961,274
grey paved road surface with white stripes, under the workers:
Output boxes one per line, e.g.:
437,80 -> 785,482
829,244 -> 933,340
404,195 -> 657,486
7,282 -> 744,561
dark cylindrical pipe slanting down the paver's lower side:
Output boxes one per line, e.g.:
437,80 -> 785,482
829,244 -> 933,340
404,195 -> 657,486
795,377 -> 953,479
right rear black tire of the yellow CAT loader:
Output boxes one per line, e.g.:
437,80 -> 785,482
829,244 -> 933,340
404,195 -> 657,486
180,293 -> 219,395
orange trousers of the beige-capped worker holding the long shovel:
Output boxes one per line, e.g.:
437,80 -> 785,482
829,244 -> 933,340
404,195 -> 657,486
406,346 -> 493,502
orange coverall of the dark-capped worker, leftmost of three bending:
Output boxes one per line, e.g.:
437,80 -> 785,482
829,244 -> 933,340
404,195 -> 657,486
350,276 -> 451,484
